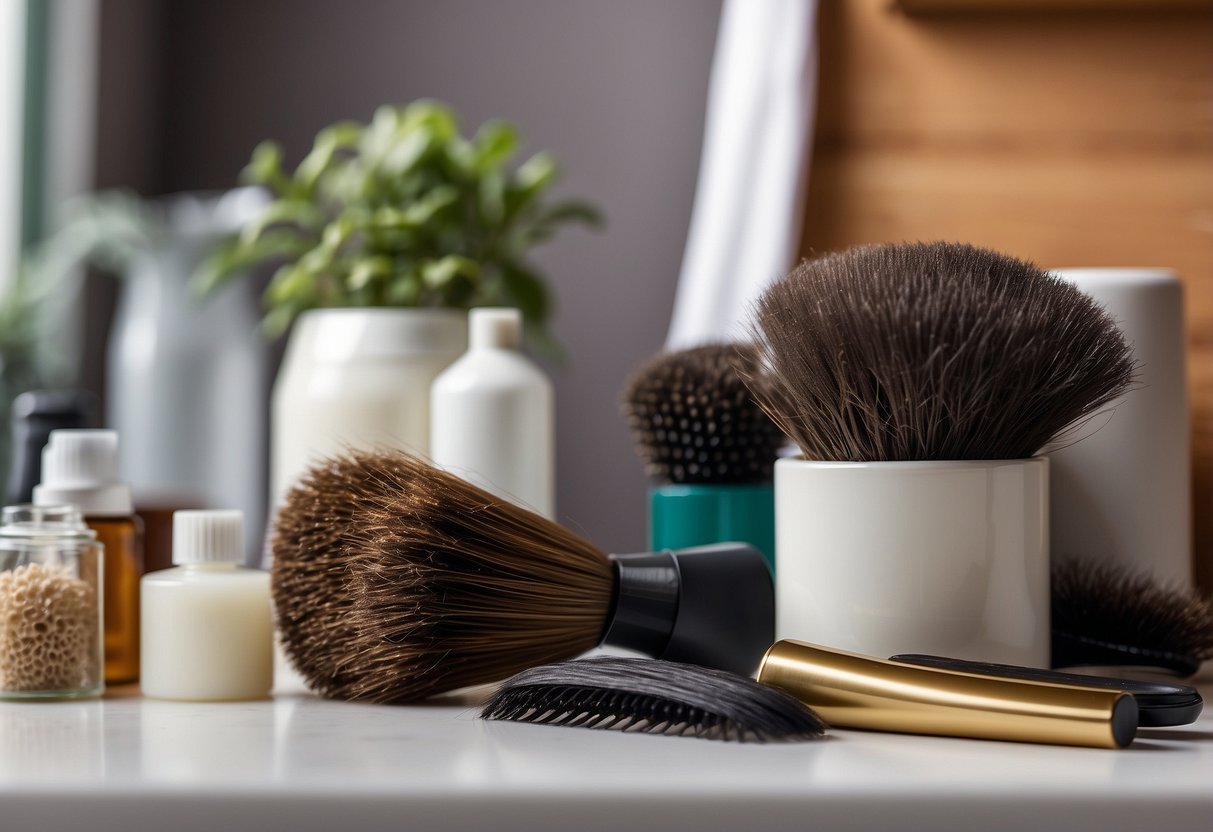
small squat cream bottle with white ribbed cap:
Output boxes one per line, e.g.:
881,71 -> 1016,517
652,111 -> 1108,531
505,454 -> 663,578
142,511 -> 274,700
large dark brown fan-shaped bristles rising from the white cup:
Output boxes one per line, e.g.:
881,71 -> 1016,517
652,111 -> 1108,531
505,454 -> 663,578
753,243 -> 1134,462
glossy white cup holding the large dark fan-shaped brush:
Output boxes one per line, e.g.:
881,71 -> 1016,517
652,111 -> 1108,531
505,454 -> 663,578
775,457 -> 1049,667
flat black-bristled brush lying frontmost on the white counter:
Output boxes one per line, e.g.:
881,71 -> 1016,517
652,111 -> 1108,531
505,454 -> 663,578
480,656 -> 825,742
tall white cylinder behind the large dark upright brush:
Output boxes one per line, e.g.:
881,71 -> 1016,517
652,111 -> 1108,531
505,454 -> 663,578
1048,268 -> 1192,586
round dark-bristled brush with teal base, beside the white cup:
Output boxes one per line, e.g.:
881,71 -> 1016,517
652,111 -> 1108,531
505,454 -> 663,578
622,344 -> 787,566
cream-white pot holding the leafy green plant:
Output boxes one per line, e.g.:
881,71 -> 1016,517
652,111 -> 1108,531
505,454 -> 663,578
270,309 -> 467,506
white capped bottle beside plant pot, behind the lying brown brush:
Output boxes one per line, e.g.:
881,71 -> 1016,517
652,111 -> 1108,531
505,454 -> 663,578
429,308 -> 556,518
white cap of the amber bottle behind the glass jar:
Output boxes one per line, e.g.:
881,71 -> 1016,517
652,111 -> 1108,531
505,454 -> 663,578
34,431 -> 133,517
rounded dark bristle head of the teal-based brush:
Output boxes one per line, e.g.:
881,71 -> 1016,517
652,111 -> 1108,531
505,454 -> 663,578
623,344 -> 787,485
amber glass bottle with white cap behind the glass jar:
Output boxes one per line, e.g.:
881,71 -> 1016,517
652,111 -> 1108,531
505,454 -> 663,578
34,431 -> 143,684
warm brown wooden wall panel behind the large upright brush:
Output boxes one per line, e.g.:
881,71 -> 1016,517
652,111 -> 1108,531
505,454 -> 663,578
803,0 -> 1213,589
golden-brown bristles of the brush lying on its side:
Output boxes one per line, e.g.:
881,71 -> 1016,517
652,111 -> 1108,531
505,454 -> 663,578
272,451 -> 614,702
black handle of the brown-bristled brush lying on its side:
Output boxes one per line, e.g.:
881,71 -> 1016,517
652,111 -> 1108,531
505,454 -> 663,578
602,543 -> 775,676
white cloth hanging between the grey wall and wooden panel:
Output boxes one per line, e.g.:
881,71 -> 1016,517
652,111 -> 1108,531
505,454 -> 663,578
666,0 -> 818,349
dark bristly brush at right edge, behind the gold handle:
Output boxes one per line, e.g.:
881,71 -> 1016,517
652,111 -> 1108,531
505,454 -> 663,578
1052,559 -> 1213,677
